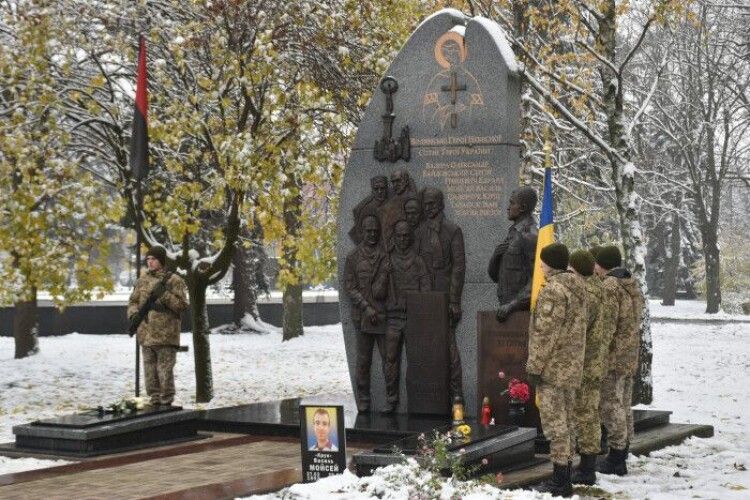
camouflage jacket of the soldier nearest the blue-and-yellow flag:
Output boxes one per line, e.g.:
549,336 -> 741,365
526,271 -> 588,389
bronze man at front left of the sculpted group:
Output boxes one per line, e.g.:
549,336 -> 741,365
344,215 -> 388,412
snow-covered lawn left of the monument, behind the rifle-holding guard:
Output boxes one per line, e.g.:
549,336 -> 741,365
0,325 -> 351,442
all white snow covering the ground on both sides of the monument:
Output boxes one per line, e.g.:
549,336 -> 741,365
0,318 -> 750,500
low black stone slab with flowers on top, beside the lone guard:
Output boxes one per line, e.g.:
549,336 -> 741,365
6,406 -> 202,458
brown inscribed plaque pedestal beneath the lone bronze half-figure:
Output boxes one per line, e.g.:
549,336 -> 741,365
477,311 -> 541,428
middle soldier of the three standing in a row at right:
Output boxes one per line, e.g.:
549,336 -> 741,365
569,250 -> 614,485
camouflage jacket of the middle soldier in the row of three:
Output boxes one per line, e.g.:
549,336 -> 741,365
583,274 -> 615,385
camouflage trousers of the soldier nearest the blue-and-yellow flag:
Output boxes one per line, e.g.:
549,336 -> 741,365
536,383 -> 575,465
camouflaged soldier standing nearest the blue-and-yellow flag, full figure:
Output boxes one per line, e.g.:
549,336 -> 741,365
526,243 -> 587,496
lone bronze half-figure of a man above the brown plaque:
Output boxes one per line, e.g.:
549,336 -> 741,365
487,187 -> 538,321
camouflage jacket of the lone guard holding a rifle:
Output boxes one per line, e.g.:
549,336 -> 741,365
128,271 -> 188,346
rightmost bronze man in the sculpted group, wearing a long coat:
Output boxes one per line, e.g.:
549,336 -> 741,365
418,187 -> 466,401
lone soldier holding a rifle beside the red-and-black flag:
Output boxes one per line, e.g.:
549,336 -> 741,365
128,245 -> 188,406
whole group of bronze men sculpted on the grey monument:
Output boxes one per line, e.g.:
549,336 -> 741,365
344,169 -> 466,413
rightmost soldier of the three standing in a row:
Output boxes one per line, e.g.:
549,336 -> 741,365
594,246 -> 645,476
